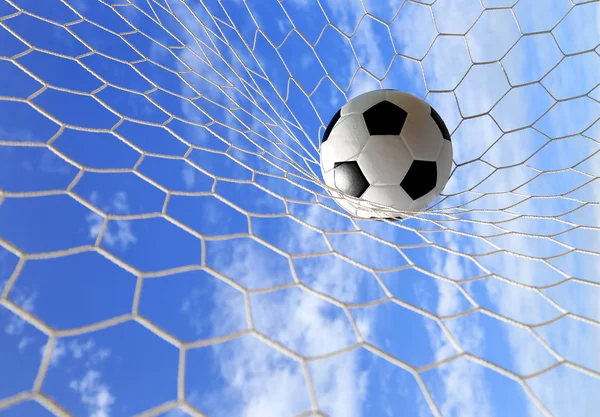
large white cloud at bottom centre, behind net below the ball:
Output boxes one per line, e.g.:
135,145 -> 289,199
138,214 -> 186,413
184,202 -> 386,417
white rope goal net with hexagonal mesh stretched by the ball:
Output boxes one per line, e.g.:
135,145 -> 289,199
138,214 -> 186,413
0,0 -> 600,416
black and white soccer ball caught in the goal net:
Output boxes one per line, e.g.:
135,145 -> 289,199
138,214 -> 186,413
320,90 -> 452,219
